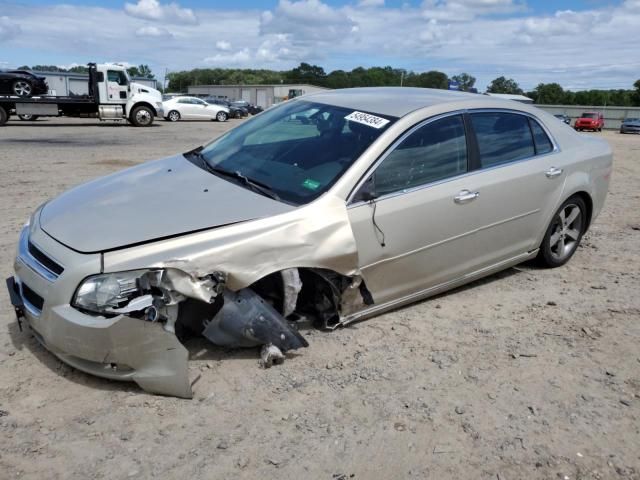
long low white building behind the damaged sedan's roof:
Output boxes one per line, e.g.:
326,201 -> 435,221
189,84 -> 327,108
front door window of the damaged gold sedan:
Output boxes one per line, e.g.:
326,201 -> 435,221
375,115 -> 467,195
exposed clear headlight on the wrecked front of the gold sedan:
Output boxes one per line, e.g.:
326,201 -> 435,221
71,270 -> 162,314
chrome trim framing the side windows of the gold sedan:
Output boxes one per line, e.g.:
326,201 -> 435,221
346,108 -> 561,208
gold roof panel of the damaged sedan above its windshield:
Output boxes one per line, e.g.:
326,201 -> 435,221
298,87 -> 488,117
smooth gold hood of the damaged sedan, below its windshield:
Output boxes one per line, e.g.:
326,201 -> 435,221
40,155 -> 295,253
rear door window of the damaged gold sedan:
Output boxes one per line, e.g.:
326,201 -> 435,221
471,112 -> 535,168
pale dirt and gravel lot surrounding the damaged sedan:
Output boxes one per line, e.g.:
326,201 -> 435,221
0,119 -> 640,480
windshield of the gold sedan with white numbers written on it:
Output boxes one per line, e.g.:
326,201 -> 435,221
200,101 -> 395,205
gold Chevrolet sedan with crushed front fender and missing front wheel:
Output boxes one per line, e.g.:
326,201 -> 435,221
7,88 -> 611,398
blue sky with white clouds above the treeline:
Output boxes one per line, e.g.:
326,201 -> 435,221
0,0 -> 640,90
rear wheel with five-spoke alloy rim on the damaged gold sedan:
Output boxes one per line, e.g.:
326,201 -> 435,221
537,196 -> 588,268
